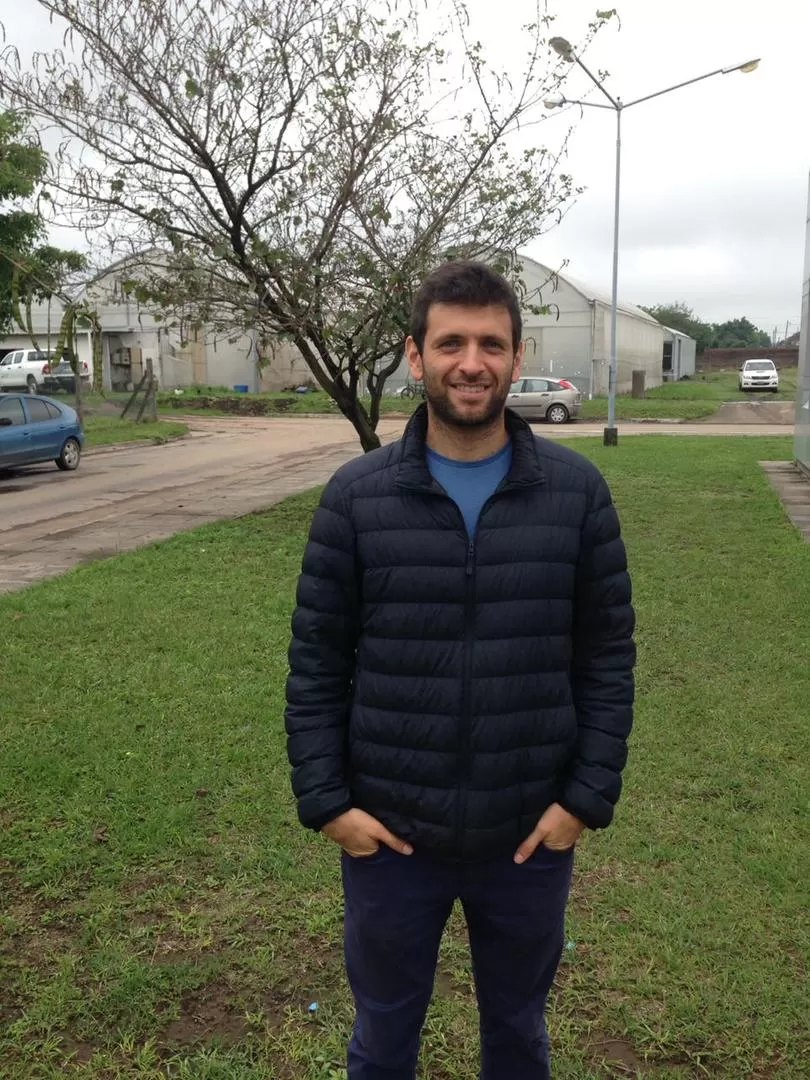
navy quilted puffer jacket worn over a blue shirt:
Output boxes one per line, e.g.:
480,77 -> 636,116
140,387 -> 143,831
286,406 -> 635,859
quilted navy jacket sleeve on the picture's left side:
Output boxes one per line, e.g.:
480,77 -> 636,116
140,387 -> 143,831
285,477 -> 360,829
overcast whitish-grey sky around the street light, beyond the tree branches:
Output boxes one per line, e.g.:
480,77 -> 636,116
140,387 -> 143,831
6,0 -> 810,337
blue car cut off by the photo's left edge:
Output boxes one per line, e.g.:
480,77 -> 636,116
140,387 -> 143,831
0,394 -> 84,471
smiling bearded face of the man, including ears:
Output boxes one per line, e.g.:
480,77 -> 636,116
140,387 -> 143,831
405,303 -> 524,428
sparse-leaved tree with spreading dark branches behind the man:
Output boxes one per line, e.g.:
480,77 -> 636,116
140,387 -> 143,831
0,0 -> 609,449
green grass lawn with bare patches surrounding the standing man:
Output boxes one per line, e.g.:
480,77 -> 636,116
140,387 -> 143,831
0,436 -> 810,1080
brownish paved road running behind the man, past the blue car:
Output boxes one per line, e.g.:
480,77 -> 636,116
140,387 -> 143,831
0,417 -> 792,592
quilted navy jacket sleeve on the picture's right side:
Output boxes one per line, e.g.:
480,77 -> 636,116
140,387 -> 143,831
559,474 -> 636,828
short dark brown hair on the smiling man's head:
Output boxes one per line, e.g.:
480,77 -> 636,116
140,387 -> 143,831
410,260 -> 523,353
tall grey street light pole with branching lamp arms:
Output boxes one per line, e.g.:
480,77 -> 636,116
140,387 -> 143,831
544,38 -> 759,446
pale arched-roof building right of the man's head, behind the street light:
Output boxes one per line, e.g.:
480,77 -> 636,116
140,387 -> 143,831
519,255 -> 673,396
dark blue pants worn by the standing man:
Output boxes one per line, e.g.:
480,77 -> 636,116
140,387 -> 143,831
342,846 -> 573,1080
